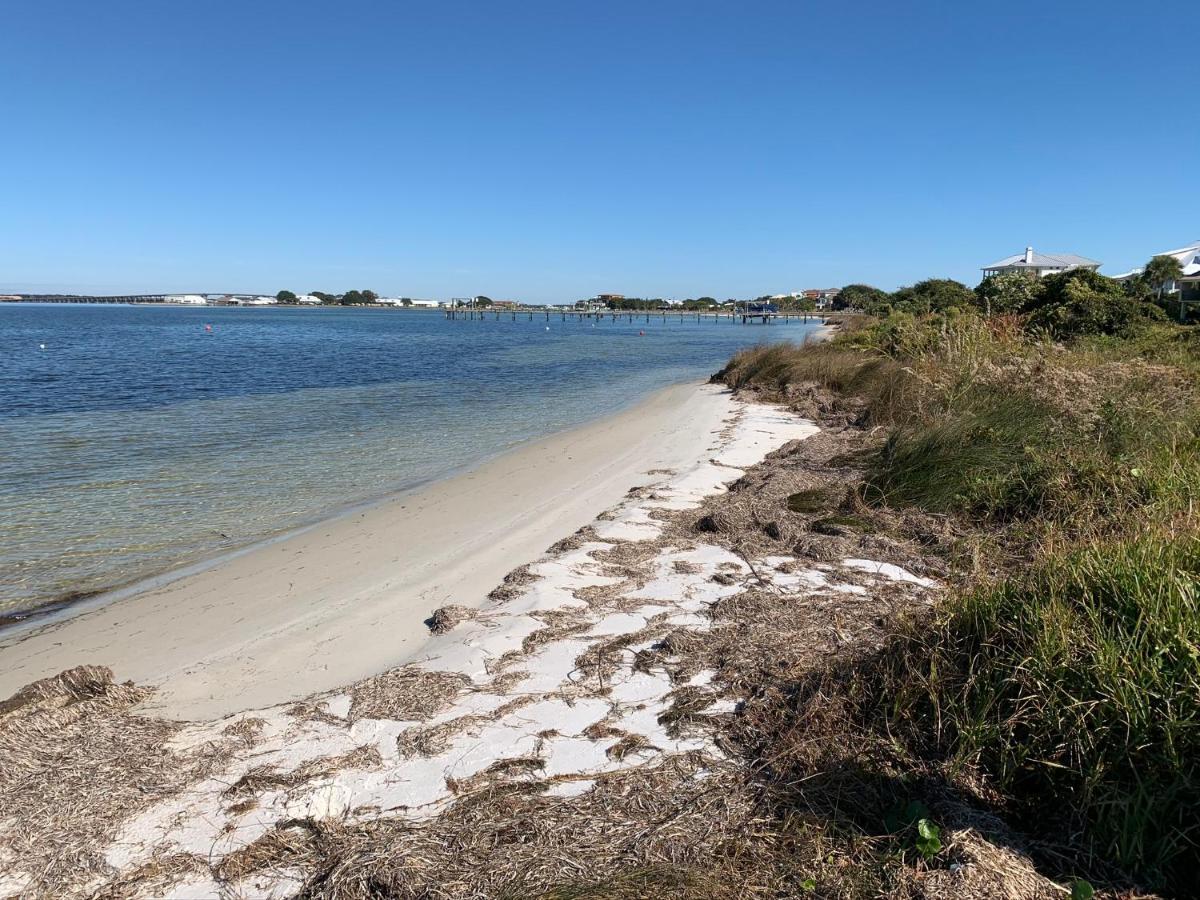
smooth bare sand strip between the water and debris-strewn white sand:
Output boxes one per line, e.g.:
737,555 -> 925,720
0,385 -> 732,719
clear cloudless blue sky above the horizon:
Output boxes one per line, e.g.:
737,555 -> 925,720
0,0 -> 1200,301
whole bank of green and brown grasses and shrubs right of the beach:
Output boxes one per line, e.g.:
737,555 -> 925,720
720,266 -> 1200,896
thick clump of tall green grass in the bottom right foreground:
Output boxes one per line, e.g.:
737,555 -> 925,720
890,533 -> 1200,895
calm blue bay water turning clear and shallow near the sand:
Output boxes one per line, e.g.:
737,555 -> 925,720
0,304 -> 810,612
